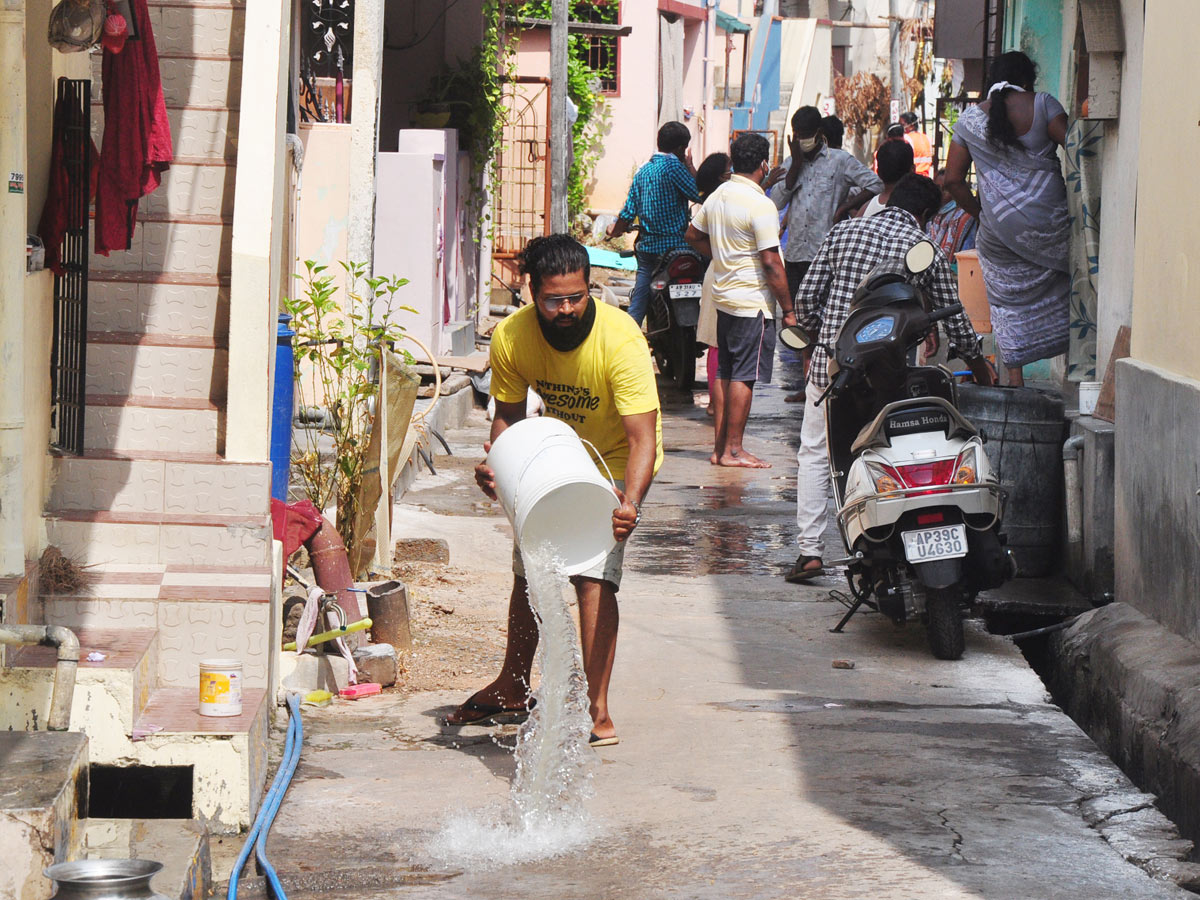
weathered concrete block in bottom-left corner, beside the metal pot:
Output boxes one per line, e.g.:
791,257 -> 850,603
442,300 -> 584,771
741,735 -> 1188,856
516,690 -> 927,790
0,731 -> 88,900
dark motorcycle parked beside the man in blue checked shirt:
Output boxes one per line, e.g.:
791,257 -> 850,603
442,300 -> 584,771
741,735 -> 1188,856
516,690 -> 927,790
622,241 -> 708,391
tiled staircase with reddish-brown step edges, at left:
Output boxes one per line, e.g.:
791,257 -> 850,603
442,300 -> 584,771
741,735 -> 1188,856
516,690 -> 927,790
28,0 -> 277,844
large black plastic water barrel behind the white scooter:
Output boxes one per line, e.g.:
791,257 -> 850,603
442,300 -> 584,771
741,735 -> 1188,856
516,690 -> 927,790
959,384 -> 1067,578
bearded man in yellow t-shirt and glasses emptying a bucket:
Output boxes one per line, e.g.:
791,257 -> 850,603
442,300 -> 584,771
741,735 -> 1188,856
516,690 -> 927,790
445,234 -> 662,746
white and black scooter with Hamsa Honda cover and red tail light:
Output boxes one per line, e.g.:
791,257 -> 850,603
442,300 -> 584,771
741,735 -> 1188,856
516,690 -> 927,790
781,241 -> 1016,660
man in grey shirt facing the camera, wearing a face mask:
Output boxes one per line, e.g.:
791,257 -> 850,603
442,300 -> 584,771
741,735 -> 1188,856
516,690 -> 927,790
764,107 -> 883,296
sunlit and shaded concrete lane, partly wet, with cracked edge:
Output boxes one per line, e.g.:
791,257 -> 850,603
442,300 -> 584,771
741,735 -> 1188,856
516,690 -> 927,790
234,367 -> 1189,900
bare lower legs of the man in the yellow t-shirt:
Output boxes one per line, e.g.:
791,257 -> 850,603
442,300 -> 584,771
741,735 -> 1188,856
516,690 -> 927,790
446,576 -> 619,738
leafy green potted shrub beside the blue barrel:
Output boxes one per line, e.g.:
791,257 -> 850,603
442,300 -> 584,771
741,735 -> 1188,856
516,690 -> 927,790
283,259 -> 416,564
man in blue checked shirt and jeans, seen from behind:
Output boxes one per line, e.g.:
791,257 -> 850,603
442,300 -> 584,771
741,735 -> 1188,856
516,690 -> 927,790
607,122 -> 700,325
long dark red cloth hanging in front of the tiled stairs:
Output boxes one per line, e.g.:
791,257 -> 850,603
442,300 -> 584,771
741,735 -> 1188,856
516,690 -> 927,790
96,0 -> 173,256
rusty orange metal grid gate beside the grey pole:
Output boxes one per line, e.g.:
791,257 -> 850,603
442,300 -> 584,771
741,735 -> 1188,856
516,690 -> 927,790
492,76 -> 551,259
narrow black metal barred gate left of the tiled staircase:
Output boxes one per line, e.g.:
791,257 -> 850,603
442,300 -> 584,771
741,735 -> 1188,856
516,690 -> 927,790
50,78 -> 91,455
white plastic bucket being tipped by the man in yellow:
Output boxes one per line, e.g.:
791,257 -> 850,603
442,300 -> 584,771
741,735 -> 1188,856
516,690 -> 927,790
487,415 -> 620,575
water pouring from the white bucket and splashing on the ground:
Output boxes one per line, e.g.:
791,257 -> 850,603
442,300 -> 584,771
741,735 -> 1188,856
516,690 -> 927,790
430,547 -> 596,869
